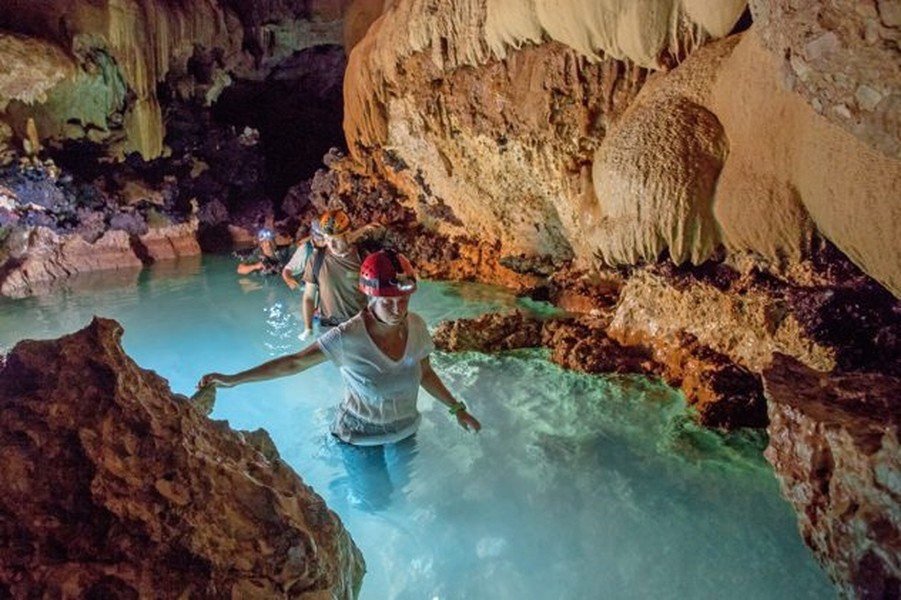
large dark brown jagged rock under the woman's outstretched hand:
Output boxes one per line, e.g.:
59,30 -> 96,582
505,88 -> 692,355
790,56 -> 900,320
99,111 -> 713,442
0,318 -> 364,600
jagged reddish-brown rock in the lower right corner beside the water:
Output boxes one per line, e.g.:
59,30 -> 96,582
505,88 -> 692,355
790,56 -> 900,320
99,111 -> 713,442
764,354 -> 901,598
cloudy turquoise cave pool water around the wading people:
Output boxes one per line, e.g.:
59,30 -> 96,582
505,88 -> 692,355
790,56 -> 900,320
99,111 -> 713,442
0,257 -> 836,600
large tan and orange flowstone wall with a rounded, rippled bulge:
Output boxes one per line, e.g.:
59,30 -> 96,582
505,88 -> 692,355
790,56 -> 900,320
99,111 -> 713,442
345,0 -> 901,296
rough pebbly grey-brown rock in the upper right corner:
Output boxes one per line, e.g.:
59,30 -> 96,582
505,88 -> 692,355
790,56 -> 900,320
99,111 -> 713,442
750,0 -> 901,160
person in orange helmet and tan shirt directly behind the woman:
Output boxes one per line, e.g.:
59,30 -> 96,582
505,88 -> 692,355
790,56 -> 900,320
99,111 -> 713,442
300,210 -> 366,341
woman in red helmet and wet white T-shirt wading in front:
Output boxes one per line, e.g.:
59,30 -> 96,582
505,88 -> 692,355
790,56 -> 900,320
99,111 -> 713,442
197,250 -> 482,508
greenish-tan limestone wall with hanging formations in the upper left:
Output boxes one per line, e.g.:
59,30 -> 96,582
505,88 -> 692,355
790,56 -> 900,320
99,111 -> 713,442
0,0 -> 347,159
